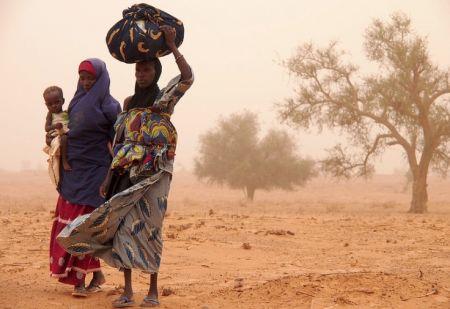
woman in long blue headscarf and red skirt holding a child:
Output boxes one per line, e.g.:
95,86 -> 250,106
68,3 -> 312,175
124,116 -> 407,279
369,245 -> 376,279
50,59 -> 121,296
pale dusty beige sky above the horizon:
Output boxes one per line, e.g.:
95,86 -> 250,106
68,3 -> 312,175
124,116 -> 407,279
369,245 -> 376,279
0,0 -> 450,173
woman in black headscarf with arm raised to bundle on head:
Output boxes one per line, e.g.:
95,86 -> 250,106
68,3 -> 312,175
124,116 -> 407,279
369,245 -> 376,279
59,26 -> 194,308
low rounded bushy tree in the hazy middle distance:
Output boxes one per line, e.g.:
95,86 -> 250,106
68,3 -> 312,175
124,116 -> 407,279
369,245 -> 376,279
195,112 -> 314,201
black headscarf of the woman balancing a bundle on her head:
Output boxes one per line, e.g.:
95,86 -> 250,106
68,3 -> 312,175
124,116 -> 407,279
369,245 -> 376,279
127,58 -> 162,110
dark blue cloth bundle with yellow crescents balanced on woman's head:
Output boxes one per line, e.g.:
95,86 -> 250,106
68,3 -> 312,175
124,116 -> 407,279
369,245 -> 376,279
106,3 -> 184,63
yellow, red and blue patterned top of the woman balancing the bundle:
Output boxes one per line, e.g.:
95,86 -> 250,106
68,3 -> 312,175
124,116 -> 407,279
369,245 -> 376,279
111,71 -> 194,182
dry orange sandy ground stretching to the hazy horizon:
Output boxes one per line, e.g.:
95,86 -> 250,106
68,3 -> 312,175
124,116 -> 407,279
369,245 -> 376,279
0,172 -> 450,309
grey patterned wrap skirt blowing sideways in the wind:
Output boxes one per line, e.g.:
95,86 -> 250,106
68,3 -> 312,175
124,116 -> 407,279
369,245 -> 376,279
57,171 -> 171,273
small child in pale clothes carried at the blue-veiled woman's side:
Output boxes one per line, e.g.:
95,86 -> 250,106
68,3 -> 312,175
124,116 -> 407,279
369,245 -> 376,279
43,86 -> 71,186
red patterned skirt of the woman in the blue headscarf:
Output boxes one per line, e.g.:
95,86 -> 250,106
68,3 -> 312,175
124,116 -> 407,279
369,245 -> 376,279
50,195 -> 100,286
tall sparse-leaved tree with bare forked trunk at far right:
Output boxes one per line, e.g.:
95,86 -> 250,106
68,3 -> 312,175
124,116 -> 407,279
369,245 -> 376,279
280,13 -> 450,213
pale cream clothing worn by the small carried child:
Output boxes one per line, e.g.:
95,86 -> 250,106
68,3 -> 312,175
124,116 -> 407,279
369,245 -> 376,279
43,111 -> 69,187
